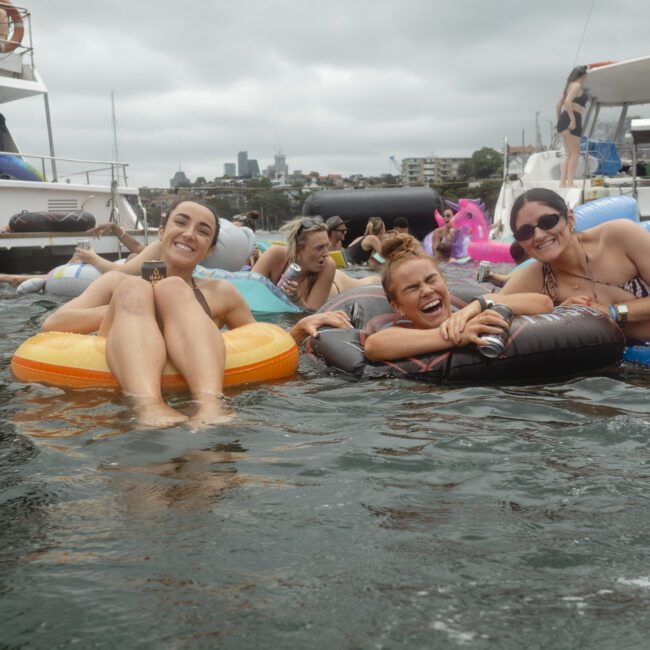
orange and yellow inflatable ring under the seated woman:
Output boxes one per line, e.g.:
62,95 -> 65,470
11,323 -> 298,389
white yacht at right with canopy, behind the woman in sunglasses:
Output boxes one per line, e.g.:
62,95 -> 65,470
494,57 -> 650,238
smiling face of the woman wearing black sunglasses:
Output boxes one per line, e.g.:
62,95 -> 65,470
515,201 -> 574,262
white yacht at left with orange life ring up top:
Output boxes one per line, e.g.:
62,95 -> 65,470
0,1 -> 148,273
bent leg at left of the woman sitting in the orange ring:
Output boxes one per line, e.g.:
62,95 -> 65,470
99,277 -> 187,428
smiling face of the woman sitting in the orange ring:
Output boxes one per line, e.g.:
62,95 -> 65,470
159,201 -> 218,267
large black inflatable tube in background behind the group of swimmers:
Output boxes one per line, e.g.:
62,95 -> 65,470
302,187 -> 443,245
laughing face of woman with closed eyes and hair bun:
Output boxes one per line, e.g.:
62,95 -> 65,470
389,257 -> 451,329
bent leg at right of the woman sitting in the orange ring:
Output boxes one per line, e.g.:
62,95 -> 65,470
154,277 -> 229,426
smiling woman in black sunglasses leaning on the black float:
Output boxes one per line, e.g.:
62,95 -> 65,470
503,188 -> 650,340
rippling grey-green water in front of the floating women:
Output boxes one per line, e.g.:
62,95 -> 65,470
0,266 -> 650,650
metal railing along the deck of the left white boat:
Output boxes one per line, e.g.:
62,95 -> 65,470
0,151 -> 129,186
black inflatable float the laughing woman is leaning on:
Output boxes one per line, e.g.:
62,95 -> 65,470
307,287 -> 625,384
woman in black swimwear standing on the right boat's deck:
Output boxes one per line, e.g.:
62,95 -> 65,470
555,65 -> 589,187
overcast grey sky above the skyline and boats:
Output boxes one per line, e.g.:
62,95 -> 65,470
5,0 -> 650,187
